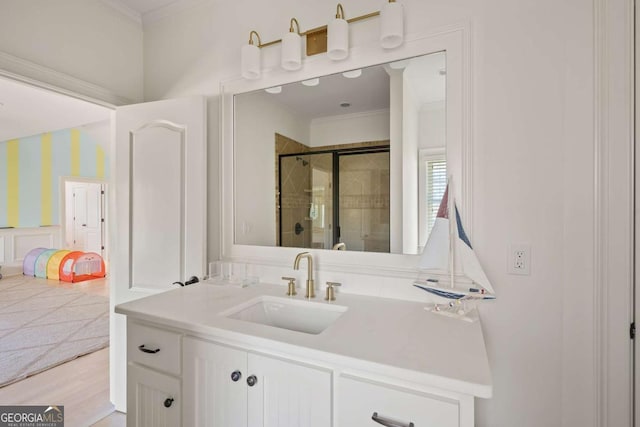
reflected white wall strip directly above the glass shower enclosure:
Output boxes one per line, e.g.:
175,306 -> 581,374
310,110 -> 389,147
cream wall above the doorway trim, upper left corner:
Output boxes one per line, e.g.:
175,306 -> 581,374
0,0 -> 143,101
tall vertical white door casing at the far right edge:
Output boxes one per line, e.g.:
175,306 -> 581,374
593,0 -> 634,427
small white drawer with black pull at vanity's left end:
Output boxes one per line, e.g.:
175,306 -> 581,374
127,322 -> 182,375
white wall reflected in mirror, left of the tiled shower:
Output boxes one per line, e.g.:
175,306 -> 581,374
235,92 -> 309,246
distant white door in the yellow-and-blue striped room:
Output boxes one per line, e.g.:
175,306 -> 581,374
71,183 -> 104,255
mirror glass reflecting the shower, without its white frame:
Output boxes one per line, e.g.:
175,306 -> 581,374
234,52 -> 447,254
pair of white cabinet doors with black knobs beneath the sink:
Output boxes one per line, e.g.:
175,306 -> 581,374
183,337 -> 332,427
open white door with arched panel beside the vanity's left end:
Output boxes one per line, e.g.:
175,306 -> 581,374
109,97 -> 207,411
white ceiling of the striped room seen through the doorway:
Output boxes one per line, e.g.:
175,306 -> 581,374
0,77 -> 111,141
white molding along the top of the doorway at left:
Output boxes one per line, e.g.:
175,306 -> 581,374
0,52 -> 133,109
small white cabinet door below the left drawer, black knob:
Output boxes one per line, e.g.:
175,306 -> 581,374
127,364 -> 182,427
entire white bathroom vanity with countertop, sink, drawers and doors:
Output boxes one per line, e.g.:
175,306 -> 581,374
115,284 -> 492,427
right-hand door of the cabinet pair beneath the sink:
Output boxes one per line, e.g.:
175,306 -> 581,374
247,354 -> 332,427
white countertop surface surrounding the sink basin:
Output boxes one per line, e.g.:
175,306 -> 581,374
115,284 -> 492,398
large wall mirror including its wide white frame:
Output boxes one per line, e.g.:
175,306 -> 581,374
222,31 -> 470,276
